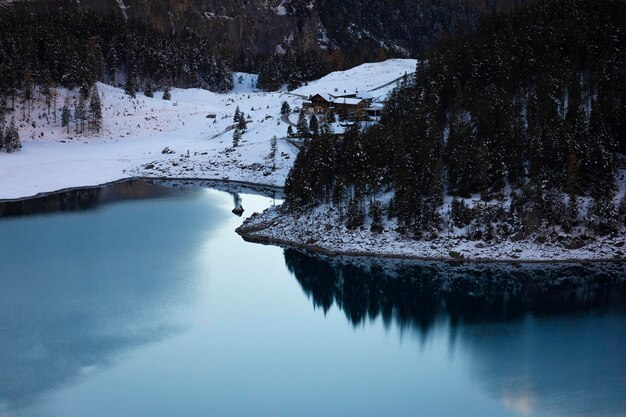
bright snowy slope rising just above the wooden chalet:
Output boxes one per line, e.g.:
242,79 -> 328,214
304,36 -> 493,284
293,59 -> 417,98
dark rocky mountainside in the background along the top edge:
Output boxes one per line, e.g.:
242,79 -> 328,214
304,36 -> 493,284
0,0 -> 524,69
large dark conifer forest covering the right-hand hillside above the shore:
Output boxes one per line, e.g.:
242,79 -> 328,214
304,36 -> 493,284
286,0 -> 626,238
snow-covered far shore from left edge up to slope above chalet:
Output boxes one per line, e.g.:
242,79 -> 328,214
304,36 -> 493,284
0,60 -> 416,200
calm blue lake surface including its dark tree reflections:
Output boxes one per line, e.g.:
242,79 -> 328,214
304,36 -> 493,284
0,183 -> 626,417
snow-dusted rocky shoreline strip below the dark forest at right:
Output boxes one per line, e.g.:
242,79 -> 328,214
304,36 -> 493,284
237,207 -> 626,262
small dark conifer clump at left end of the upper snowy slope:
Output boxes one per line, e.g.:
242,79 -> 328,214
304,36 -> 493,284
257,50 -> 329,91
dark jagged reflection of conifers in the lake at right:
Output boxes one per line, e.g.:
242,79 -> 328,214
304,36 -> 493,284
285,249 -> 626,333
